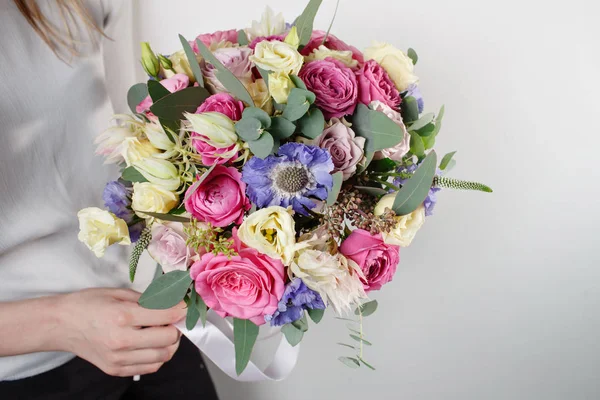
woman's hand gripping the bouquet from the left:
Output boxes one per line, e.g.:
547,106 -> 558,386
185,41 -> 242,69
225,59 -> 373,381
56,289 -> 186,376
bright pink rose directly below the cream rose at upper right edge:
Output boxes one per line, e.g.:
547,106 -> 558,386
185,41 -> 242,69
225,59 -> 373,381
356,60 -> 400,109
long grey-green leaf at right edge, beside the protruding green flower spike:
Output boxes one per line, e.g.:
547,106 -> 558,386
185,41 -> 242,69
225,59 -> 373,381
392,151 -> 437,215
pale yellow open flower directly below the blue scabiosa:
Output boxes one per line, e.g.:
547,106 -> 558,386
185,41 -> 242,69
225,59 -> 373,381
238,206 -> 296,265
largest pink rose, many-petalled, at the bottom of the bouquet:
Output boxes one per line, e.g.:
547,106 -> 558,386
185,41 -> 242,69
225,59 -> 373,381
190,229 -> 285,325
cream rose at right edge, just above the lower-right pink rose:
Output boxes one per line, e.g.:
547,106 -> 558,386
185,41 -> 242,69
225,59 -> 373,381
374,193 -> 425,247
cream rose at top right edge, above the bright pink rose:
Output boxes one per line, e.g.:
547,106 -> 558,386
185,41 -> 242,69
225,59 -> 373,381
364,43 -> 419,92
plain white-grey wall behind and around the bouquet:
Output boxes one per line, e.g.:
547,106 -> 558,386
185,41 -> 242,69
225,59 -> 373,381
123,0 -> 600,400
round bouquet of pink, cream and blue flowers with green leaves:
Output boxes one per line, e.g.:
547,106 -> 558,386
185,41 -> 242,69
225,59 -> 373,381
78,0 -> 491,374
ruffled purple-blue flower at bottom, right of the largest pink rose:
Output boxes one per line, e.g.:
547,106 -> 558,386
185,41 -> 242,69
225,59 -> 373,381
265,278 -> 325,326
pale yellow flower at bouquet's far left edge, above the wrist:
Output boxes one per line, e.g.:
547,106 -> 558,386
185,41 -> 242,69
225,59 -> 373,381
77,207 -> 131,258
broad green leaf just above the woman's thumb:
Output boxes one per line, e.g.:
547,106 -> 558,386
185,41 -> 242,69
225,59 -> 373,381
138,271 -> 192,310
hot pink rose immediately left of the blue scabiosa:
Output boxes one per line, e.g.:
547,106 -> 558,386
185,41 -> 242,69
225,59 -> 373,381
185,165 -> 250,227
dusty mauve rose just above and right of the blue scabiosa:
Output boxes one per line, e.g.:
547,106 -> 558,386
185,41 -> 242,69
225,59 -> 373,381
316,118 -> 365,180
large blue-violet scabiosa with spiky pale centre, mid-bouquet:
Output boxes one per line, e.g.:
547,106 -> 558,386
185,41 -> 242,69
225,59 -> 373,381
242,142 -> 333,215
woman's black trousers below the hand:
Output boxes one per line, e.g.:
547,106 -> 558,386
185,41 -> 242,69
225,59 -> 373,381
0,336 -> 218,400
